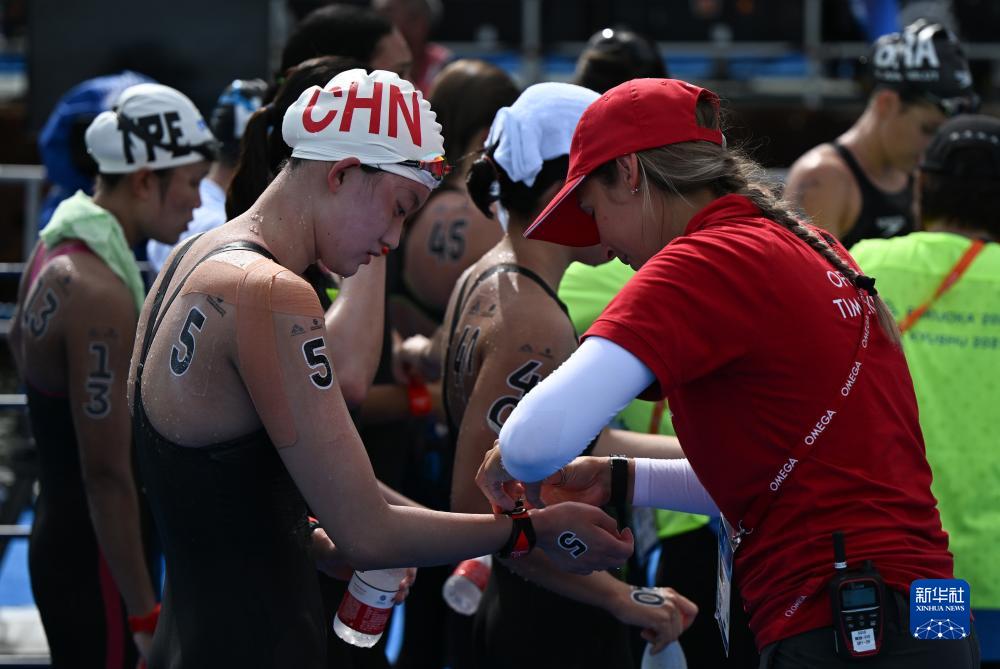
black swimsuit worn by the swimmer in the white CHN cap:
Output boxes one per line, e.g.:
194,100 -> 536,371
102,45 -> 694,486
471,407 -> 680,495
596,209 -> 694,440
132,240 -> 326,669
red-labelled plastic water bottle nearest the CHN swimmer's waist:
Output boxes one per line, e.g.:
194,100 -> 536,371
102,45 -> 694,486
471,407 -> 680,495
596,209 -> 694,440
333,569 -> 406,648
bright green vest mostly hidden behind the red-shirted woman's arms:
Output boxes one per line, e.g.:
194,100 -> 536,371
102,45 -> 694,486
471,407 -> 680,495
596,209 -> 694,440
559,260 -> 709,539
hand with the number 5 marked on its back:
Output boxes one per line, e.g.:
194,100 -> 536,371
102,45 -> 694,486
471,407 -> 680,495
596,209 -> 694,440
529,502 -> 635,574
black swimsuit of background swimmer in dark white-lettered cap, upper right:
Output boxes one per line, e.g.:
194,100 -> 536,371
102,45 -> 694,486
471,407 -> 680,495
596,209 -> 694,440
833,142 -> 916,249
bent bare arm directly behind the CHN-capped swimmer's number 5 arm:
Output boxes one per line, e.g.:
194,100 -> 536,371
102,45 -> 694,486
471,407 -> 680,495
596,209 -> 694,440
326,257 -> 385,407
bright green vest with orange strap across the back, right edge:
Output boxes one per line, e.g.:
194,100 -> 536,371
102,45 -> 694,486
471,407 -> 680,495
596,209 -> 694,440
851,232 -> 1000,609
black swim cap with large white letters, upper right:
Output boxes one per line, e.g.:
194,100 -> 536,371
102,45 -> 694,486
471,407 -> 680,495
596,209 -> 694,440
870,19 -> 979,116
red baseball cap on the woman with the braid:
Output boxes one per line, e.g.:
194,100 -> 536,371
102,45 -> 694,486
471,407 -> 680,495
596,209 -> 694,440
524,79 -> 723,246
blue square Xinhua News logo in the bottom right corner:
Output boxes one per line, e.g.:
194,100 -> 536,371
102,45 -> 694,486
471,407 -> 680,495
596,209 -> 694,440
910,578 -> 972,640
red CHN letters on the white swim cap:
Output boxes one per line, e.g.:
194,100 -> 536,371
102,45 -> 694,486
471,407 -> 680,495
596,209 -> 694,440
302,81 -> 423,146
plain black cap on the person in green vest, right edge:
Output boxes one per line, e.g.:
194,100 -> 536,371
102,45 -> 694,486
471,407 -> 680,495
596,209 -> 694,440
920,114 -> 1000,180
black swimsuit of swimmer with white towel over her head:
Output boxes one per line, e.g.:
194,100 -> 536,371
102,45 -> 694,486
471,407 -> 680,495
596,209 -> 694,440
441,263 -> 633,669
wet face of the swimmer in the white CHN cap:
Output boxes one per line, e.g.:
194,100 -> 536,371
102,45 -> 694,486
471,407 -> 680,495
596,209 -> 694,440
315,159 -> 430,276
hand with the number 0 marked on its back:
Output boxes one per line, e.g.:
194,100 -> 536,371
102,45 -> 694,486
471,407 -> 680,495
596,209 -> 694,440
608,583 -> 698,654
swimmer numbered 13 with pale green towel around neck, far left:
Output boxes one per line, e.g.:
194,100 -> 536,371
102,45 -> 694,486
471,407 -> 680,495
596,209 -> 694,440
10,84 -> 215,669
